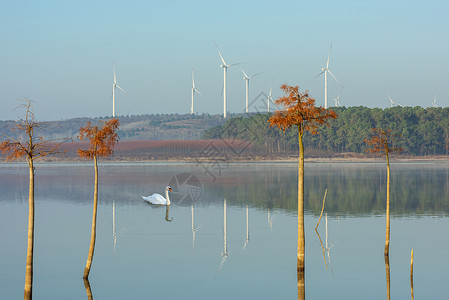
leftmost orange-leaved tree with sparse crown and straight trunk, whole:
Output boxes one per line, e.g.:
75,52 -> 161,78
0,99 -> 67,299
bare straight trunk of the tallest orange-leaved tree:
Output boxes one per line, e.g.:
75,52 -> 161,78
297,126 -> 305,272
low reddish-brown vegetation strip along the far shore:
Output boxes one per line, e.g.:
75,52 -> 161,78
0,139 -> 449,162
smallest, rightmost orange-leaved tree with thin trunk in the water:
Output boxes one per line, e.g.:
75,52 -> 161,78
364,128 -> 403,256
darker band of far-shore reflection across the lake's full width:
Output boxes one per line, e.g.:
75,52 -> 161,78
0,162 -> 449,216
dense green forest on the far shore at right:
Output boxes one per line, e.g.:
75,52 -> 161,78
202,106 -> 449,156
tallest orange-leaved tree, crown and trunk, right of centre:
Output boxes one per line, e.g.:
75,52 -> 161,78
268,84 -> 337,272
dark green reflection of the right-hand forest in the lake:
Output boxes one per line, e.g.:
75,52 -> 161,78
200,163 -> 449,215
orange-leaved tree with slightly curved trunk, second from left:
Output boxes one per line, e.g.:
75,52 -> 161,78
78,119 -> 119,279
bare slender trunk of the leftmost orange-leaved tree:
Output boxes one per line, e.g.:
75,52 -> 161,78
23,157 -> 34,300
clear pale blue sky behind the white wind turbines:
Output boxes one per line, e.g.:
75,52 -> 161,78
0,0 -> 449,121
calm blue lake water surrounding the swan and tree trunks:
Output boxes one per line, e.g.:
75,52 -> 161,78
0,162 -> 449,299
